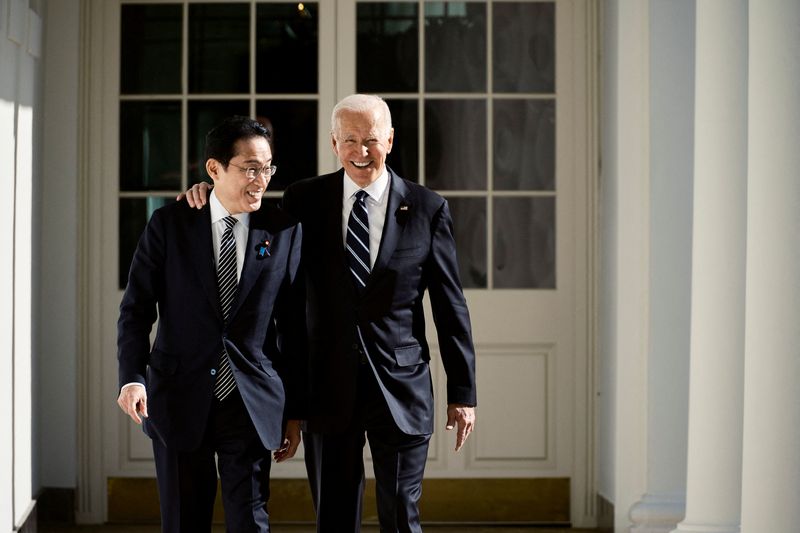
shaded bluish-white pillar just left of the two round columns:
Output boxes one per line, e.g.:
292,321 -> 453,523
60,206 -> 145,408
622,0 -> 695,533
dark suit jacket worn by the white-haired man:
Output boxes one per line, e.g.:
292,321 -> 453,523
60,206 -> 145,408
284,169 -> 476,435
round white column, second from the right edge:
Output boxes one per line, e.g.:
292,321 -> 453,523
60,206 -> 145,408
675,0 -> 748,533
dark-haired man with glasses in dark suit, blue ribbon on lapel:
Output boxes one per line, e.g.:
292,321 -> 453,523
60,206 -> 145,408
117,117 -> 306,533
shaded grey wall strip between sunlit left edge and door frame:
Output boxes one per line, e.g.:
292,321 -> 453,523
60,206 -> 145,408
35,0 -> 80,488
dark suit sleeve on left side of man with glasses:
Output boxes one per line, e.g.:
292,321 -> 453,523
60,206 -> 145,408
117,211 -> 164,388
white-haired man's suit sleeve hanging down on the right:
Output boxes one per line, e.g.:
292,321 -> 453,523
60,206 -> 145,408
427,197 -> 477,406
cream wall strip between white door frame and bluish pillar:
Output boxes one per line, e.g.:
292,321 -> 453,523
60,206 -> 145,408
598,0 -> 650,531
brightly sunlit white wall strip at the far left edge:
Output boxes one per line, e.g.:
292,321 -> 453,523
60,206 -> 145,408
0,0 -> 41,531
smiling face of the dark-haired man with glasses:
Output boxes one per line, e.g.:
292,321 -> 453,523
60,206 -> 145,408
206,136 -> 272,215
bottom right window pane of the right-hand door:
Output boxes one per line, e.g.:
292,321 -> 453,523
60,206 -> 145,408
492,197 -> 556,289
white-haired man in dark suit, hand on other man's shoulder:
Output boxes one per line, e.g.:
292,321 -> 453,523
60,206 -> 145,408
183,94 -> 476,533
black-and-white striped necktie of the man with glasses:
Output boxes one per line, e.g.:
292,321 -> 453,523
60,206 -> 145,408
214,216 -> 238,400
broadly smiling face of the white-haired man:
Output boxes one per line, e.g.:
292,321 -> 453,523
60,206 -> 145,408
331,109 -> 394,188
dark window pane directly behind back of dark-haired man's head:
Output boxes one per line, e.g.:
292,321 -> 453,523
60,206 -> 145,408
187,100 -> 250,185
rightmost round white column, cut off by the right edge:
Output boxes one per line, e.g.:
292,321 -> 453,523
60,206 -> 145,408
742,0 -> 800,533
